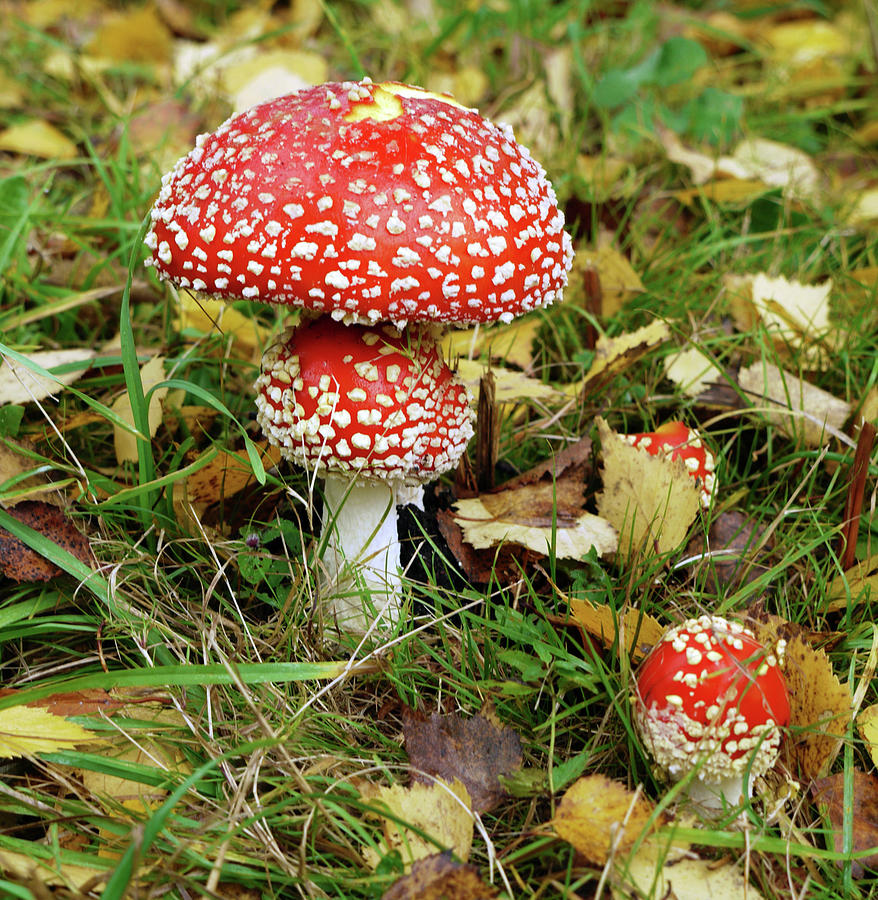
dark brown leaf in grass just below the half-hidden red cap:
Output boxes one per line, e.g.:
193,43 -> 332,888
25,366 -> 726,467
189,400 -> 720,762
686,510 -> 773,594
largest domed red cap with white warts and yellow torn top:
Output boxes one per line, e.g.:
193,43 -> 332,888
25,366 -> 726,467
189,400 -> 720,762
146,80 -> 573,324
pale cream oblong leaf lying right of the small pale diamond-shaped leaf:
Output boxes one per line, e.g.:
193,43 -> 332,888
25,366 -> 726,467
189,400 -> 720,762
738,362 -> 851,447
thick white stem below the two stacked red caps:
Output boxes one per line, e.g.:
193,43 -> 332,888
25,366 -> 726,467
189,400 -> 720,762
321,473 -> 402,632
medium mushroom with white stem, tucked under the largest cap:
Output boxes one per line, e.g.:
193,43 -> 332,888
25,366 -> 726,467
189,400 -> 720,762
256,316 -> 473,631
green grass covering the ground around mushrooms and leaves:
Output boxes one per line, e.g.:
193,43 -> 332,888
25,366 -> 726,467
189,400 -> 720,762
0,0 -> 878,900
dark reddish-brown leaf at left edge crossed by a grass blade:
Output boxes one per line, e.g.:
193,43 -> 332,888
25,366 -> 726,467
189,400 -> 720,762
0,500 -> 92,582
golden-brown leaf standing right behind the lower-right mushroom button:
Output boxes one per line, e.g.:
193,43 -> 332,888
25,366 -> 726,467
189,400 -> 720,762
782,636 -> 851,782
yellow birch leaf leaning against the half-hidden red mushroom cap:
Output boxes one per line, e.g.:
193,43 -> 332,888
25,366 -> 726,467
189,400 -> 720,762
596,418 -> 701,556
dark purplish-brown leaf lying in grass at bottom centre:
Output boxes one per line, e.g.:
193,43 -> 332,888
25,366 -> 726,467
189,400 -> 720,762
402,708 -> 521,813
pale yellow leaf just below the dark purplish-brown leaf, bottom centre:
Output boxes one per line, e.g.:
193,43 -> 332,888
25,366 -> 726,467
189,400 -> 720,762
363,778 -> 473,869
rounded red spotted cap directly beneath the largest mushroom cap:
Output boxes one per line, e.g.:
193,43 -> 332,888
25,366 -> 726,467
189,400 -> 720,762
256,316 -> 473,485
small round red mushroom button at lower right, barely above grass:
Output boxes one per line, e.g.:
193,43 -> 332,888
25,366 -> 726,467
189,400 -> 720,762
634,615 -> 790,812
